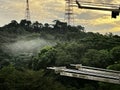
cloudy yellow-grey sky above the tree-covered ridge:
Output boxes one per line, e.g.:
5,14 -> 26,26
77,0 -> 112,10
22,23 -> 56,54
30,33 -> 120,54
0,0 -> 120,35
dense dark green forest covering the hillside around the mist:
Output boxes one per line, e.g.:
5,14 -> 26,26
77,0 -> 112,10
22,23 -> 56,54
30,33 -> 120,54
0,20 -> 120,90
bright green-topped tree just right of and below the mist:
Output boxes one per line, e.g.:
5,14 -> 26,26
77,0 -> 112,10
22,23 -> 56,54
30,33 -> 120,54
29,47 -> 56,70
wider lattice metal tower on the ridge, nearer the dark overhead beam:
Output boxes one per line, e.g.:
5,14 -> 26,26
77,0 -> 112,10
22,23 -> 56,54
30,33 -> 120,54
65,0 -> 74,25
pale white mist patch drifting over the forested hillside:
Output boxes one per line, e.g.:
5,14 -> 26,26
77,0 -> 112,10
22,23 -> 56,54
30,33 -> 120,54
3,37 -> 56,55
